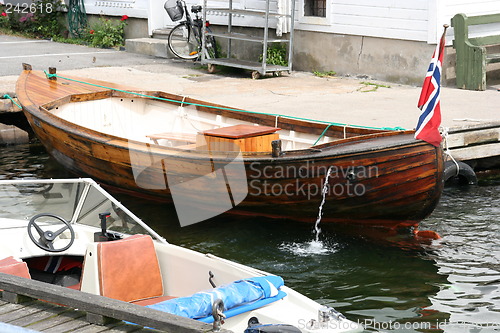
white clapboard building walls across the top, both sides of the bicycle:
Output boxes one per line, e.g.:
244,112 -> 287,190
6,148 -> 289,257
85,0 -> 500,44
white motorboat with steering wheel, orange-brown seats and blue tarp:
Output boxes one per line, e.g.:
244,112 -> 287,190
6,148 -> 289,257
0,179 -> 362,333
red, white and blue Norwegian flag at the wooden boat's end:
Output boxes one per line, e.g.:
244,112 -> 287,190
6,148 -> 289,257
415,26 -> 447,147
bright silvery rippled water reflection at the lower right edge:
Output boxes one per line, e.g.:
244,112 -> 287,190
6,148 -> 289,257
422,186 -> 500,330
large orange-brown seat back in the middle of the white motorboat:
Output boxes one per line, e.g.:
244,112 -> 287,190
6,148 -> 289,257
97,235 -> 163,302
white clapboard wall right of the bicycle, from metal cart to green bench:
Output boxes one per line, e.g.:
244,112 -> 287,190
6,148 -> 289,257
209,0 -> 500,44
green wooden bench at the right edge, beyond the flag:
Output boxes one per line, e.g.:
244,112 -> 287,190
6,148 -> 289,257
451,14 -> 500,90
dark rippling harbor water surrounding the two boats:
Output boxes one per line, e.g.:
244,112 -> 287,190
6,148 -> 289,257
0,145 -> 500,333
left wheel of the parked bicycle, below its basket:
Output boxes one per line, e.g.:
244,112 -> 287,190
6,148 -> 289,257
168,22 -> 198,60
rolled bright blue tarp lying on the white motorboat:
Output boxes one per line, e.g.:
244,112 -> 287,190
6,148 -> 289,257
147,275 -> 286,319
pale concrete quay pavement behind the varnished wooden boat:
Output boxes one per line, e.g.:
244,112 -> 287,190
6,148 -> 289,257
0,35 -> 500,129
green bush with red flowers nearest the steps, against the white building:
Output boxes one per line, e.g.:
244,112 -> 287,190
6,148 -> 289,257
85,15 -> 128,47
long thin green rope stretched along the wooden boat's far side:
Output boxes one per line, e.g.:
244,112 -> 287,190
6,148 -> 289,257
44,71 -> 405,142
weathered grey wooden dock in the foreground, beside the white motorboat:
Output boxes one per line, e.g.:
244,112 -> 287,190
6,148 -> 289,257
0,273 -> 230,333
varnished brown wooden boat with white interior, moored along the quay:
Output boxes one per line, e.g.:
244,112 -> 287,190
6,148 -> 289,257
17,65 -> 443,228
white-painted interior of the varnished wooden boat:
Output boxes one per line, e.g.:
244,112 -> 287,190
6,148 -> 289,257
49,97 -> 340,151
